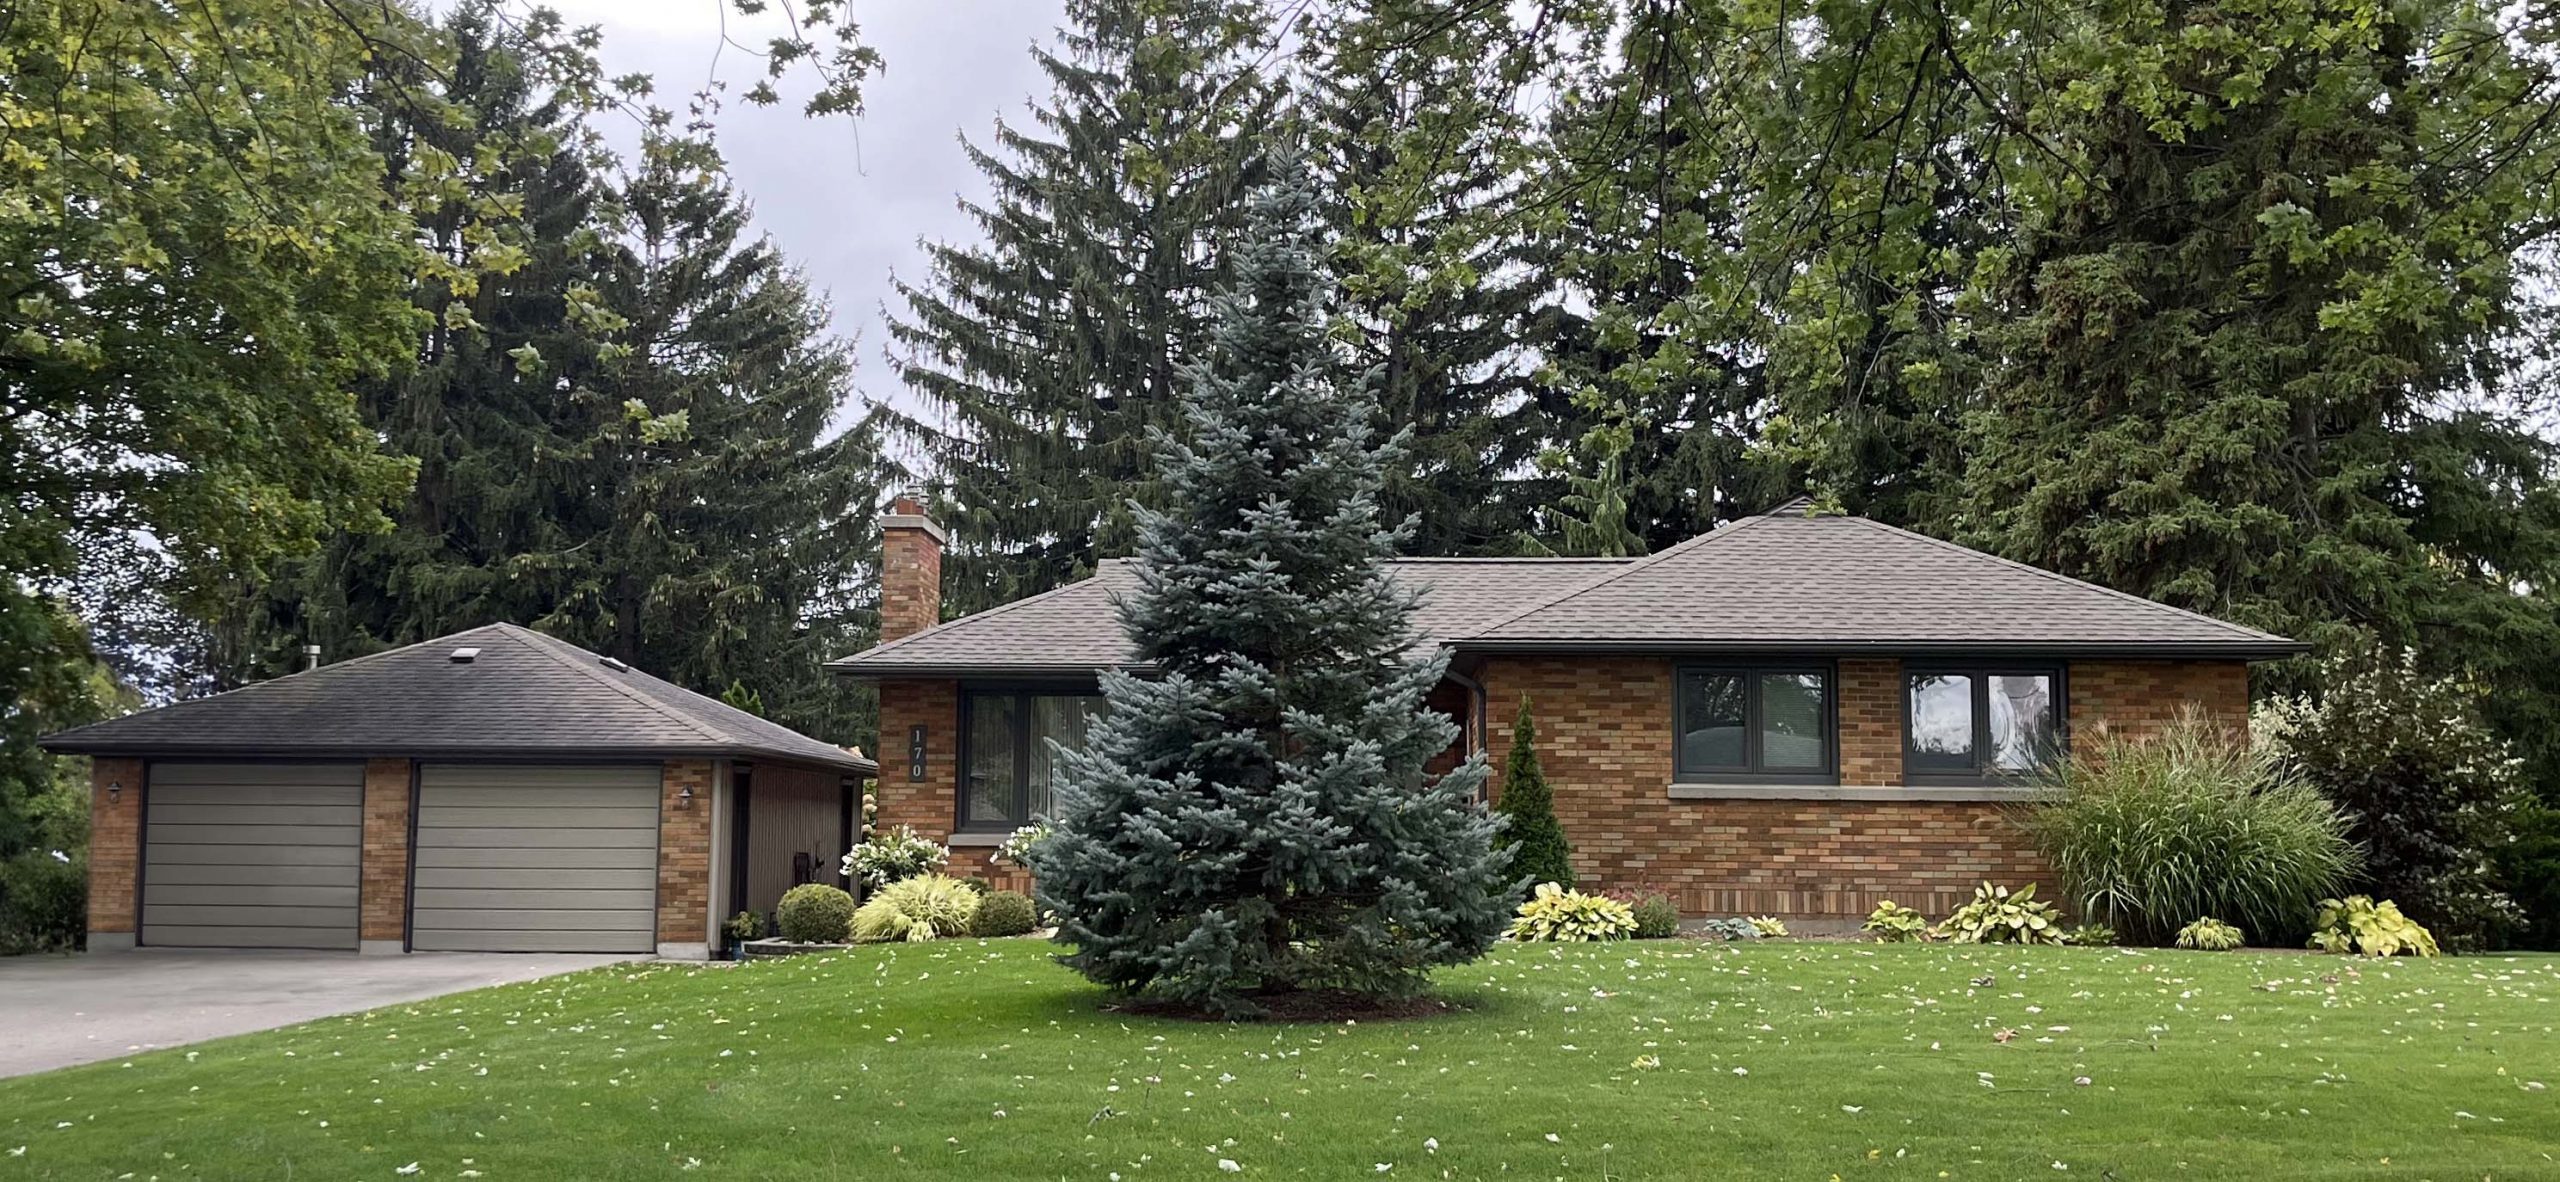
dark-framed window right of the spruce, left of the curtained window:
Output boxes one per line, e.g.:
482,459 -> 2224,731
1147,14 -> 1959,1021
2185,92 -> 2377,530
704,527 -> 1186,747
1674,663 -> 1833,783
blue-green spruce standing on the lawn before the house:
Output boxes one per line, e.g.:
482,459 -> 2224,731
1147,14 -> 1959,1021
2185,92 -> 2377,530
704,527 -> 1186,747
1034,159 -> 1510,1016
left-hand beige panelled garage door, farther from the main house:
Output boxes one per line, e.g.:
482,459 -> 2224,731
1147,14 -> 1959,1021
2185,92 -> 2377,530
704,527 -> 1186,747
141,762 -> 364,949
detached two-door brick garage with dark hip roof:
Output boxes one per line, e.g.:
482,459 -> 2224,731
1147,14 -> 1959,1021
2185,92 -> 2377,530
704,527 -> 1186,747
44,624 -> 876,959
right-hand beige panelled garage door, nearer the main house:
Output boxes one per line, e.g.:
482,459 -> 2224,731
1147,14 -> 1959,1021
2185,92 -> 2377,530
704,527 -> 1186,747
410,762 -> 658,952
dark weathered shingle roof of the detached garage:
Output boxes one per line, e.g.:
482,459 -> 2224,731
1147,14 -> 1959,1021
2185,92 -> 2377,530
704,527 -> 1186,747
44,624 -> 878,775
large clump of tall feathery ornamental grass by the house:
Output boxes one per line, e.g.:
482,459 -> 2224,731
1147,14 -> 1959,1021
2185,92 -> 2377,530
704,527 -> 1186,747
2020,714 -> 2355,944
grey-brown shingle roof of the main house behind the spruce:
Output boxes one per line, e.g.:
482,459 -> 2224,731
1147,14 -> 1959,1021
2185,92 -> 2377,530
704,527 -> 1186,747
829,501 -> 2304,678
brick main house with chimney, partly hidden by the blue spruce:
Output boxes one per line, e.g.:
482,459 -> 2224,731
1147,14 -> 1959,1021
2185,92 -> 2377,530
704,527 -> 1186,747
832,499 -> 2301,918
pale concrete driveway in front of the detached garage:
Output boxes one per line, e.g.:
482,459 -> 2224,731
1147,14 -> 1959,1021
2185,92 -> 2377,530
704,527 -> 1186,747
0,949 -> 637,1077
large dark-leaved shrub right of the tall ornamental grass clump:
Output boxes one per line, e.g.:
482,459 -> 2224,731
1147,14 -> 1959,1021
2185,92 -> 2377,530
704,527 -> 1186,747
2258,650 -> 2532,947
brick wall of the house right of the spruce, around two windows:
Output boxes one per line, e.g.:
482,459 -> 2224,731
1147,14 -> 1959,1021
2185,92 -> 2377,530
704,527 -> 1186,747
1477,655 -> 2248,916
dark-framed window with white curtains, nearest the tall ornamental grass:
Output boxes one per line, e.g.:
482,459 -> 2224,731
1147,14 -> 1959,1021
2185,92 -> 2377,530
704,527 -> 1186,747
1902,665 -> 2063,783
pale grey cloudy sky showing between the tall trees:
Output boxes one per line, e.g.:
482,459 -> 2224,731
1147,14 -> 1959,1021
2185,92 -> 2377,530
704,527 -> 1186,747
545,0 -> 1062,424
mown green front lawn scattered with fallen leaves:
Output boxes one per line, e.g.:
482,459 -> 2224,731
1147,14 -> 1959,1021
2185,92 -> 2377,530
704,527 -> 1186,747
0,939 -> 2560,1182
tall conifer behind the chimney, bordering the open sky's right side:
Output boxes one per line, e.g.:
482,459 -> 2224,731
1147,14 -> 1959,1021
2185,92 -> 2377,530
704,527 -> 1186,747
891,0 -> 1275,611
